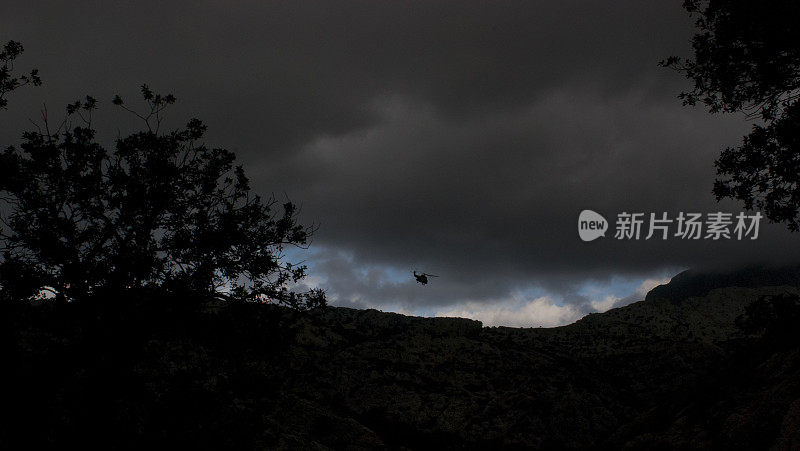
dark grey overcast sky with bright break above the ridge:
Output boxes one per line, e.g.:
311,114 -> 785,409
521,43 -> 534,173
0,0 -> 800,326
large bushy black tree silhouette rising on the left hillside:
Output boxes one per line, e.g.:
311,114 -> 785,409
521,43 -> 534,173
0,85 -> 325,308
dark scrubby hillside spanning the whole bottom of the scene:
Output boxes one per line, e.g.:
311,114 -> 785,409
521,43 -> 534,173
0,274 -> 800,449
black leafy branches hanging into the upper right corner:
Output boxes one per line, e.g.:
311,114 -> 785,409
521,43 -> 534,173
660,0 -> 800,231
